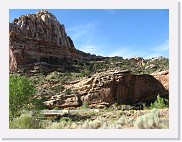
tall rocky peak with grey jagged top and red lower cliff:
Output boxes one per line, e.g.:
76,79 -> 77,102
9,10 -> 100,72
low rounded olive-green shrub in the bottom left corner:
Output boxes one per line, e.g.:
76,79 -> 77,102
9,113 -> 41,129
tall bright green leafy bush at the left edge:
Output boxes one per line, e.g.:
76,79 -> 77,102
9,75 -> 35,117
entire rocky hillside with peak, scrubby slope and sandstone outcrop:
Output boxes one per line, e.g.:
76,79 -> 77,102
9,10 -> 169,127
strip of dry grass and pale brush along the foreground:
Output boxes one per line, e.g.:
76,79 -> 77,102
10,109 -> 169,129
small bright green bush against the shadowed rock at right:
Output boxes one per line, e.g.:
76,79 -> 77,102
150,95 -> 168,109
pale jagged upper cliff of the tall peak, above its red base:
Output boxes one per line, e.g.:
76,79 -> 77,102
9,10 -> 74,48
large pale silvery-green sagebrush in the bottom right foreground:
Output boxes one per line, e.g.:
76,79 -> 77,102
134,109 -> 167,129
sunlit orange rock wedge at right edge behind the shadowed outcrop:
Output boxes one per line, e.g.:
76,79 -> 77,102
151,70 -> 169,90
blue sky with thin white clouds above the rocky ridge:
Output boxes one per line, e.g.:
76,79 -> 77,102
9,9 -> 169,58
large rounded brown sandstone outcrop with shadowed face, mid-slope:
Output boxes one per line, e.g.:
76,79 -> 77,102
44,70 -> 168,107
